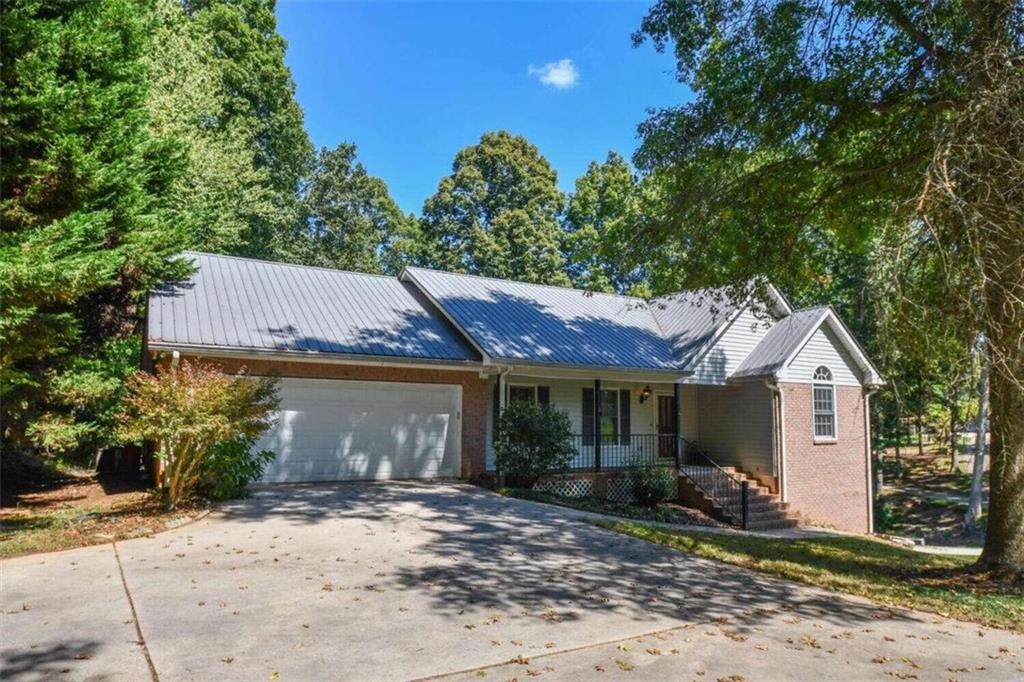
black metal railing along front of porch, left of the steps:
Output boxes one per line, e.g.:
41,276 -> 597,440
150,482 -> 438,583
568,433 -> 678,471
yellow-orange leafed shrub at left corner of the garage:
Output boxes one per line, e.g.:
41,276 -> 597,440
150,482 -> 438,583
118,360 -> 278,507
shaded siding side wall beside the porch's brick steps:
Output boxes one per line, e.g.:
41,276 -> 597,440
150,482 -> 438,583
696,383 -> 774,474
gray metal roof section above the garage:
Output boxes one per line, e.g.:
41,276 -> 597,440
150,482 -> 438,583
147,252 -> 479,360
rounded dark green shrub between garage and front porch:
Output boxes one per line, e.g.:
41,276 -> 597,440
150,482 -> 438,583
495,401 -> 575,487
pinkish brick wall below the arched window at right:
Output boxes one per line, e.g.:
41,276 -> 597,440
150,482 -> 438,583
780,383 -> 869,532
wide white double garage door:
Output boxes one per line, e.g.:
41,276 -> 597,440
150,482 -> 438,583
256,379 -> 462,482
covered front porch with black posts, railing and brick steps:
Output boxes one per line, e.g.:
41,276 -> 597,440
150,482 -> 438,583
487,374 -> 784,527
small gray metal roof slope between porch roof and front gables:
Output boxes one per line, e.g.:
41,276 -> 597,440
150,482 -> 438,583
650,289 -> 739,369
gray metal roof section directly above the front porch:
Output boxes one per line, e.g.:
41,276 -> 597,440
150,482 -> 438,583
403,267 -> 679,371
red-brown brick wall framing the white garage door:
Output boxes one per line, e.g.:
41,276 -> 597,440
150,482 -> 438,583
161,356 -> 487,478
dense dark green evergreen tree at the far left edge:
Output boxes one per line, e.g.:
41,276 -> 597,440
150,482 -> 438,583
0,0 -> 185,453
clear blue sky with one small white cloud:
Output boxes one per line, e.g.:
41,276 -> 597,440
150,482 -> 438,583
278,0 -> 689,213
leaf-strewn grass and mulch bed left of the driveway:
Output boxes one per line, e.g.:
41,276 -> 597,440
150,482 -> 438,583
0,485 -> 200,558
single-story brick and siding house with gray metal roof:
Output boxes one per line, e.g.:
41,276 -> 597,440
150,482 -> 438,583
144,252 -> 882,531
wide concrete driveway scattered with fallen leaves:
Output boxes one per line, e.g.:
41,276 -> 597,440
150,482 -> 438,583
0,483 -> 1024,680
